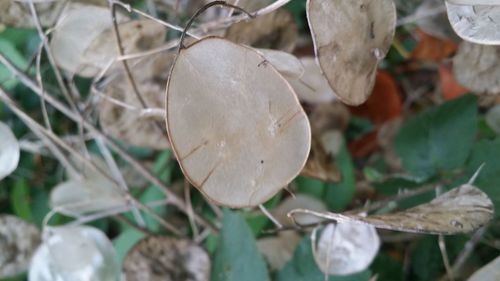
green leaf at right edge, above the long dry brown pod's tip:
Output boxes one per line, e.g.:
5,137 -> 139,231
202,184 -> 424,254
467,138 -> 500,217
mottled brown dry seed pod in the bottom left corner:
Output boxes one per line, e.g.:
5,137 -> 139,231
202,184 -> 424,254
0,215 -> 41,279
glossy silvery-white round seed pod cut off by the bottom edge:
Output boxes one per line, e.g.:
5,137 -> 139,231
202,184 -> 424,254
29,226 -> 118,281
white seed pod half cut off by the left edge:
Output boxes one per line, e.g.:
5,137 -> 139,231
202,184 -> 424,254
0,122 -> 21,180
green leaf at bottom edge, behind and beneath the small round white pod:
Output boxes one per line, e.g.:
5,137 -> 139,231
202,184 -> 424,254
278,237 -> 371,281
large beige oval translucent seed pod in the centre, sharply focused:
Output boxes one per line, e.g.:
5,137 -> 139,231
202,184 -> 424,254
166,37 -> 311,207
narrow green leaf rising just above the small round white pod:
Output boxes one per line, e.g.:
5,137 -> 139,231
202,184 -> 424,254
325,142 -> 355,211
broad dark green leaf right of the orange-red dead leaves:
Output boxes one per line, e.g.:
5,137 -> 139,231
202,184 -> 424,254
395,95 -> 477,179
